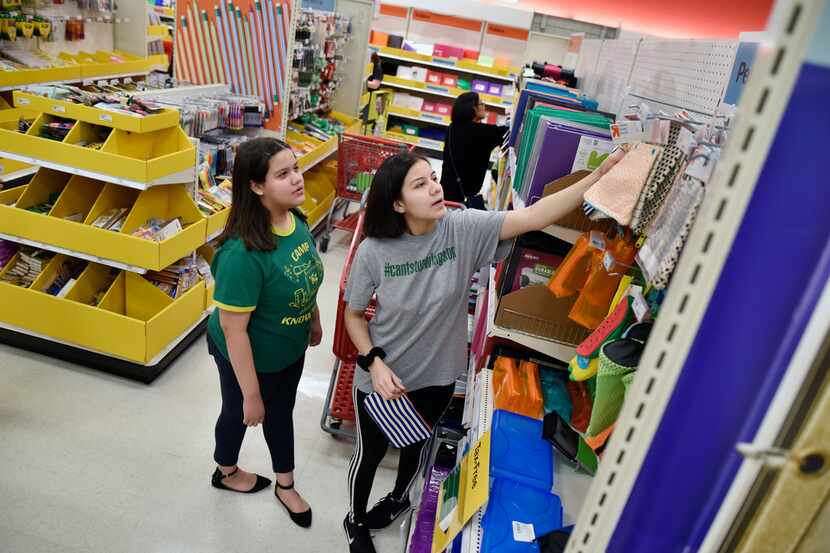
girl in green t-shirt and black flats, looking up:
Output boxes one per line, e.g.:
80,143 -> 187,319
208,138 -> 323,528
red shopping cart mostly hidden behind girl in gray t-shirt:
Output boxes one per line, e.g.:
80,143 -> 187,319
320,202 -> 464,438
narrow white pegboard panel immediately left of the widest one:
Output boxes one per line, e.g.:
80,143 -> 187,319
593,39 -> 641,113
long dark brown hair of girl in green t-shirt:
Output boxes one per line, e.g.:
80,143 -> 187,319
219,137 -> 306,252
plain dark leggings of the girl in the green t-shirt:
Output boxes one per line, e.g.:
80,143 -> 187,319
208,336 -> 305,472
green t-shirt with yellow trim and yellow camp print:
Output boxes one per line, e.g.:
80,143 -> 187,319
208,213 -> 323,373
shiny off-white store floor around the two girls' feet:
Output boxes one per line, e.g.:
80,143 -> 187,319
0,233 -> 400,553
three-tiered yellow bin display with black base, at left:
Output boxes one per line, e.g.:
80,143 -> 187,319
0,99 -> 207,382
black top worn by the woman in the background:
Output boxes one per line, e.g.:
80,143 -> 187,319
441,122 -> 509,203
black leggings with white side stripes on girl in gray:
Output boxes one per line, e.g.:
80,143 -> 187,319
348,382 -> 455,522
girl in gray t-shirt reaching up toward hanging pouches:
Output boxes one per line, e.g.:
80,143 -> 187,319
343,152 -> 623,553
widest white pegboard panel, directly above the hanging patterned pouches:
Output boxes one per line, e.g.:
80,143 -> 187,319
629,40 -> 738,115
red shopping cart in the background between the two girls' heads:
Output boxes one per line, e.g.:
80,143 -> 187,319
320,133 -> 414,252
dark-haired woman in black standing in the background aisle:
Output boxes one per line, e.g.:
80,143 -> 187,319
441,92 -> 509,209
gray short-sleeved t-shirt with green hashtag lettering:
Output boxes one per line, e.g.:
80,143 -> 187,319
345,209 -> 509,393
